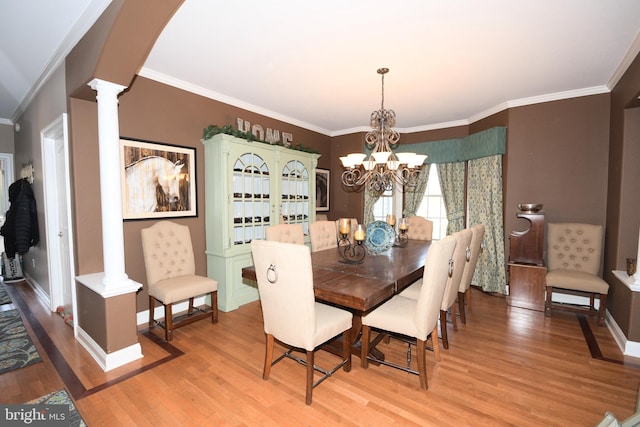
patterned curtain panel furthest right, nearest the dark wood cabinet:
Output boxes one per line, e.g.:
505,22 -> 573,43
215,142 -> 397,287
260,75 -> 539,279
467,155 -> 507,294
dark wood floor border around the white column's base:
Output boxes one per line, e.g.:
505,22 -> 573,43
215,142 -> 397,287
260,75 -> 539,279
5,283 -> 184,400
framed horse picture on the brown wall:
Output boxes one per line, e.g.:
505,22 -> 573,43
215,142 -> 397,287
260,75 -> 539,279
120,137 -> 198,220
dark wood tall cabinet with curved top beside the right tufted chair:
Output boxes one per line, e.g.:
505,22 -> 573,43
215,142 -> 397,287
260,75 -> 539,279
507,212 -> 547,311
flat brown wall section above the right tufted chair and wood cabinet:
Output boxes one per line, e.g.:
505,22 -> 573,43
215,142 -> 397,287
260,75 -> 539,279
504,95 -> 609,255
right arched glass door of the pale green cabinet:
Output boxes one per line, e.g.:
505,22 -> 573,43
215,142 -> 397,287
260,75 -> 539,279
280,160 -> 309,235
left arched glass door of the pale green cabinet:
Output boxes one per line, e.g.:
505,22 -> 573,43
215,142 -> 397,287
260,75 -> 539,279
233,153 -> 271,245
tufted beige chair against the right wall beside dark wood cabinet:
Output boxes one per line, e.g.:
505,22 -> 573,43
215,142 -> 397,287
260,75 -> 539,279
545,223 -> 609,326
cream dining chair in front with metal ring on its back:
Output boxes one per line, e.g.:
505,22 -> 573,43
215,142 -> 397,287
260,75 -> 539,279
251,240 -> 353,405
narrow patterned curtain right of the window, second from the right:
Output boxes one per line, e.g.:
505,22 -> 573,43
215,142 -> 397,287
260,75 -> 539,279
438,162 -> 465,235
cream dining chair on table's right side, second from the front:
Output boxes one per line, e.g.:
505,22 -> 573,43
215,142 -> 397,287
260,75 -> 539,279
400,228 -> 472,349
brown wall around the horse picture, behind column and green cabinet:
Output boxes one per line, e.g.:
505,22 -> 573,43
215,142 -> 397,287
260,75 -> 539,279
70,77 -> 331,311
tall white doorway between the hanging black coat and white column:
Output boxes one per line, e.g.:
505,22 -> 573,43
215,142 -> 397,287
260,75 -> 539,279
41,114 -> 77,335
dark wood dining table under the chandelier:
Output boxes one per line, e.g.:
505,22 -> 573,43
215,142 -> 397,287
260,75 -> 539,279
242,239 -> 431,360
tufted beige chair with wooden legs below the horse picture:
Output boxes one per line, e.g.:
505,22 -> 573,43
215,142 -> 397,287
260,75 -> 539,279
141,221 -> 218,341
